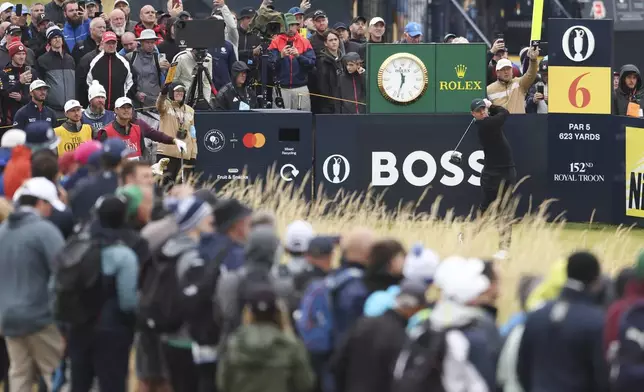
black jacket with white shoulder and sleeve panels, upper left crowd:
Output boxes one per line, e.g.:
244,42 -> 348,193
85,51 -> 134,110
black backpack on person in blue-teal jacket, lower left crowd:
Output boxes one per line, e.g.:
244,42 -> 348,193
54,232 -> 107,326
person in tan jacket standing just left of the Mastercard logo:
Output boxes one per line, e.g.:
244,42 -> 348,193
157,83 -> 197,184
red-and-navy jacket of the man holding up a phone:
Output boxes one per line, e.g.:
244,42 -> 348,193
268,34 -> 315,88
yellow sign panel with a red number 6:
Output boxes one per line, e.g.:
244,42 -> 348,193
548,66 -> 612,114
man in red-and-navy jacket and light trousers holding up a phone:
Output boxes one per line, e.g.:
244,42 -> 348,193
268,14 -> 315,111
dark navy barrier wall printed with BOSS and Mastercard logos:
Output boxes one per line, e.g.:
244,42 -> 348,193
196,111 -> 644,225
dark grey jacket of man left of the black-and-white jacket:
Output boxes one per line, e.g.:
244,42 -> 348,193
38,50 -> 76,112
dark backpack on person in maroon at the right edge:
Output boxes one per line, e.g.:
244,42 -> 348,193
610,300 -> 644,392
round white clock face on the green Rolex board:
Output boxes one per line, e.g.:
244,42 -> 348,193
378,53 -> 428,105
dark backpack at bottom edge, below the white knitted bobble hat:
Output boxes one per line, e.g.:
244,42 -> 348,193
392,320 -> 461,392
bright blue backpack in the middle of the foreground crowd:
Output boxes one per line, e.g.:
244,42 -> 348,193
295,268 -> 363,354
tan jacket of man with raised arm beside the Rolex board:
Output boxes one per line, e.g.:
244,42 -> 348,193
487,60 -> 539,114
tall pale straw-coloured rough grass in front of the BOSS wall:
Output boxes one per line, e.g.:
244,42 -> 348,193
215,169 -> 644,320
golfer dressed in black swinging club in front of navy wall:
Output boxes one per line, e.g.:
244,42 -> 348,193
470,98 -> 517,254
